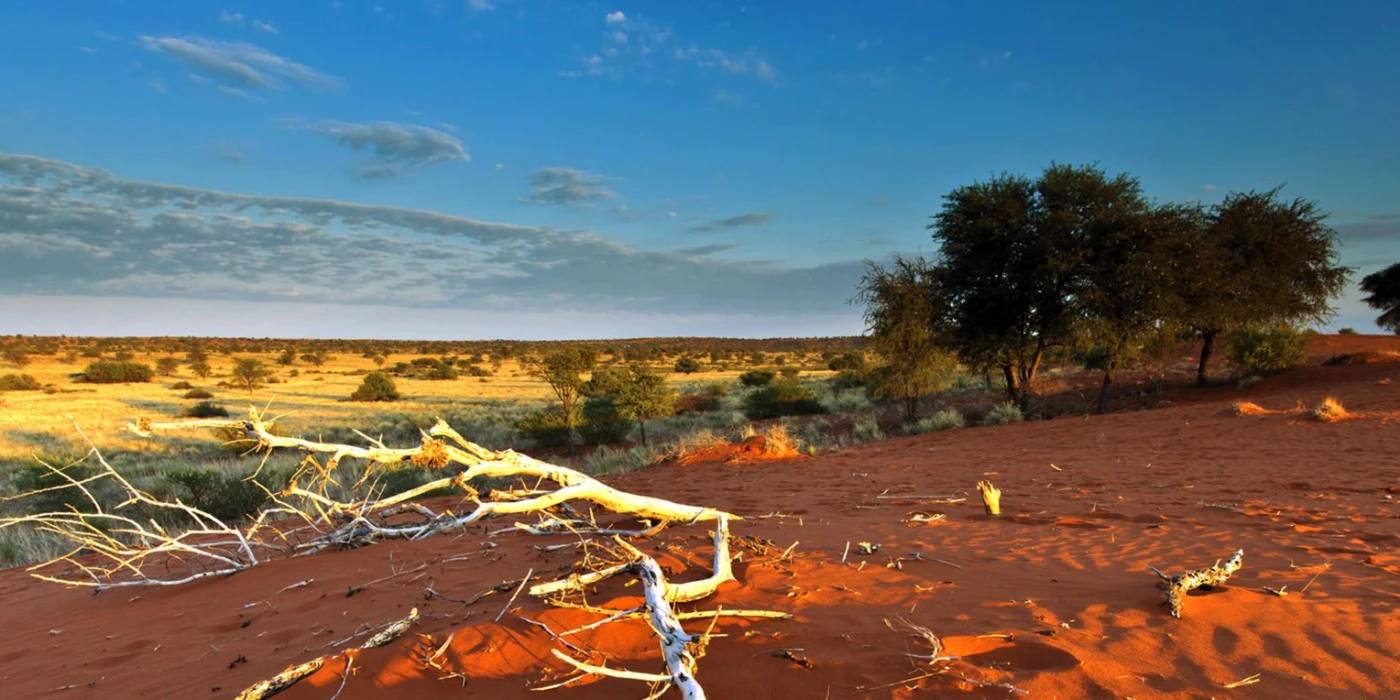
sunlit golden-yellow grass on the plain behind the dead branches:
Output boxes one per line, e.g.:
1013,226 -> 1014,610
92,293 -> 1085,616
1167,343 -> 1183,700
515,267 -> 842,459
0,353 -> 833,459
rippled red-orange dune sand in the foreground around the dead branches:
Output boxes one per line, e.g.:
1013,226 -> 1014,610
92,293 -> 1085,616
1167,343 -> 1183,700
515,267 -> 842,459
0,355 -> 1400,700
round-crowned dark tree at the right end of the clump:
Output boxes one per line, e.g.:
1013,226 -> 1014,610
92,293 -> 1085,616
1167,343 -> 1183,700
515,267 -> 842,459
1173,188 -> 1351,384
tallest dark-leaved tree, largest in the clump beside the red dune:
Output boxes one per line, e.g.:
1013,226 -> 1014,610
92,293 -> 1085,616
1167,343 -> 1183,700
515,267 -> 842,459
930,164 -> 1144,409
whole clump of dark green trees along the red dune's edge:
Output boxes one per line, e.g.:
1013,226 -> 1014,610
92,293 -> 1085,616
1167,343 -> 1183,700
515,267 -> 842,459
857,165 -> 1349,419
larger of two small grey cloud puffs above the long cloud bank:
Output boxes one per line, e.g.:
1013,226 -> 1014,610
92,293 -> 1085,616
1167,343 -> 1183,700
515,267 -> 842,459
295,120 -> 472,178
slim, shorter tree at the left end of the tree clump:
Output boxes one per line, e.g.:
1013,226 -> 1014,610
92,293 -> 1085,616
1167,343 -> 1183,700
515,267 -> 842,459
854,255 -> 958,423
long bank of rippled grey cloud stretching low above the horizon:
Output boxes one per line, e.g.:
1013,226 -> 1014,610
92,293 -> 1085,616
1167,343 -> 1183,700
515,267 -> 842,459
0,154 -> 862,314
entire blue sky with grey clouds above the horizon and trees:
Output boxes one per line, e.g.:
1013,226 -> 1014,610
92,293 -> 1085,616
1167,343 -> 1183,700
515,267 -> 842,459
0,0 -> 1400,337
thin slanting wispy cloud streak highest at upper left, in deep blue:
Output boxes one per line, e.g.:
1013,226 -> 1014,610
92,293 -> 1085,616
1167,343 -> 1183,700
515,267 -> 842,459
140,36 -> 342,90
